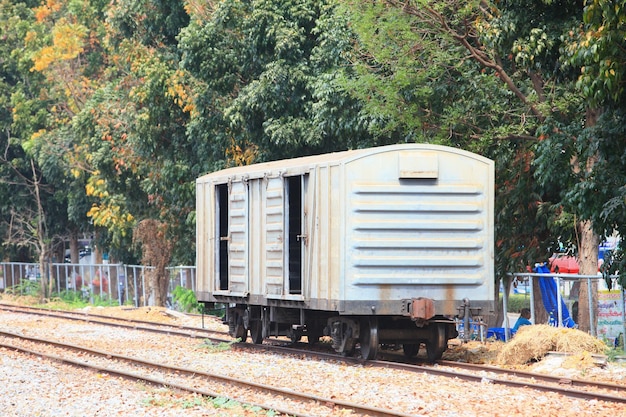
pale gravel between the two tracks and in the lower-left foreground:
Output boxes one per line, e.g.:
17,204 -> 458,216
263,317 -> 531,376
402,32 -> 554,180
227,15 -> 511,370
0,304 -> 626,417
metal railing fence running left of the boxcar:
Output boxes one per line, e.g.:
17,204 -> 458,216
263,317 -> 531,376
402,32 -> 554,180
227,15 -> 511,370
0,262 -> 196,307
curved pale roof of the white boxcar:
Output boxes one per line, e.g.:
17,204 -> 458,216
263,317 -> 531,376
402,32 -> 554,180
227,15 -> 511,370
197,143 -> 491,182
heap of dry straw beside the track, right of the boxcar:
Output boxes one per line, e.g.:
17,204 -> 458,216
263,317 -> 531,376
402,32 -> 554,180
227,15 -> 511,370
496,324 -> 607,365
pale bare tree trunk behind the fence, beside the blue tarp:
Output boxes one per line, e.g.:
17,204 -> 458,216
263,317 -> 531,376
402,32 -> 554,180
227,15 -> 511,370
578,220 -> 600,333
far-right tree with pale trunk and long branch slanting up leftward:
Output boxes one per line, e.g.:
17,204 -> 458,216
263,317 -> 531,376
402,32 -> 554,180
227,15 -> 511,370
378,0 -> 625,330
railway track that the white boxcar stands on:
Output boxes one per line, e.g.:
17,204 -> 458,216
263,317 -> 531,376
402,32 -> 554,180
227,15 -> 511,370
0,305 -> 626,403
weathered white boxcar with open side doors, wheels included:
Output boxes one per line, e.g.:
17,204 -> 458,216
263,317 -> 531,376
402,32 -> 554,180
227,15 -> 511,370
196,144 -> 494,360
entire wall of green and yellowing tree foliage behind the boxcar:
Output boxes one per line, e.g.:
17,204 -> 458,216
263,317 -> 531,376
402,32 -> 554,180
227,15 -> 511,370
0,0 -> 626,302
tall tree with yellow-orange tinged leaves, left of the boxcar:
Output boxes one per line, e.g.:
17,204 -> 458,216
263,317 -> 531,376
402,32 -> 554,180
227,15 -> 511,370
25,0 -> 198,261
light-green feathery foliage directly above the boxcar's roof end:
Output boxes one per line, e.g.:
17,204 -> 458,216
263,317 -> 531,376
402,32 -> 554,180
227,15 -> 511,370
345,2 -> 502,145
